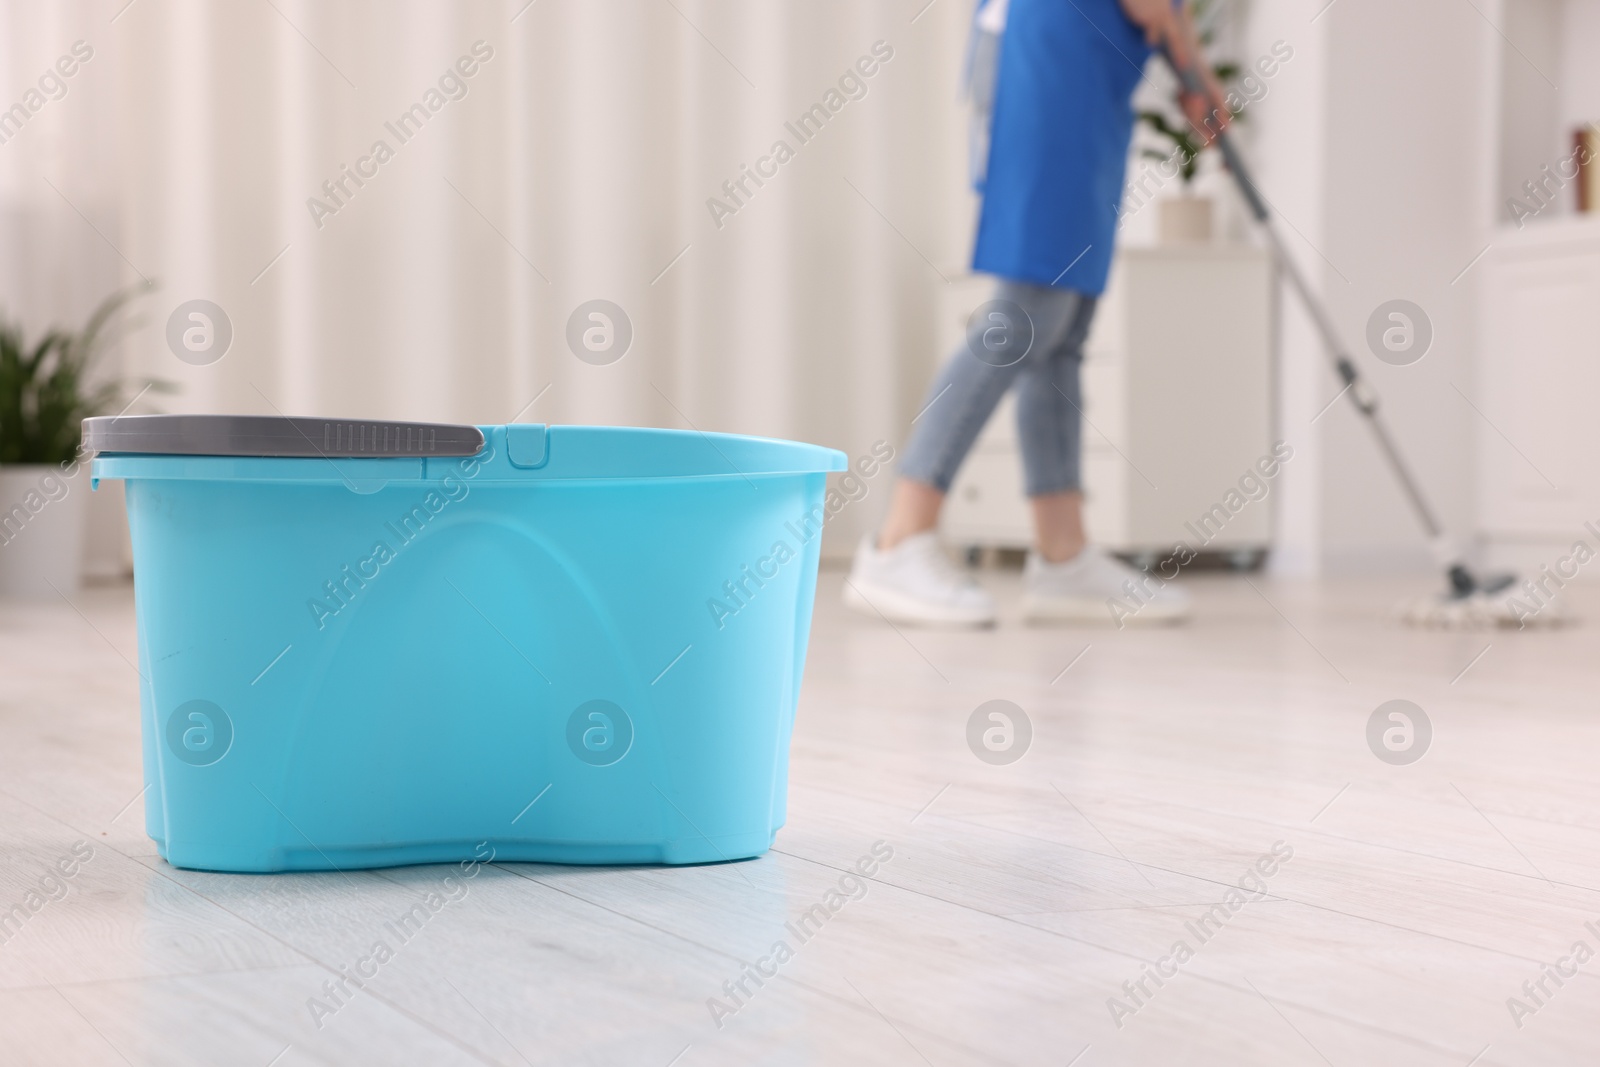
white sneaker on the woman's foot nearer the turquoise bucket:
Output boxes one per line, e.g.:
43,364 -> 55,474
845,530 -> 995,625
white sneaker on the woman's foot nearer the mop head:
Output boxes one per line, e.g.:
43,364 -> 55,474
1022,545 -> 1189,630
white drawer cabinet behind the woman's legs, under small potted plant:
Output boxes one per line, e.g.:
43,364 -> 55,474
941,245 -> 1272,553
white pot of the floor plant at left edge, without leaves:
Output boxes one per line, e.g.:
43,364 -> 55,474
0,464 -> 90,597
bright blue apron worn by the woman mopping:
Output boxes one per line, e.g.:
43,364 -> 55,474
973,0 -> 1150,296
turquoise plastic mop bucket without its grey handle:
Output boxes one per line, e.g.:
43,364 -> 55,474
93,419 -> 845,872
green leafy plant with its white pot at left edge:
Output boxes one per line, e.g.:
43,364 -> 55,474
0,283 -> 160,597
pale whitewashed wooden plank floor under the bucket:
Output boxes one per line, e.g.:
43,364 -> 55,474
0,573 -> 1600,1067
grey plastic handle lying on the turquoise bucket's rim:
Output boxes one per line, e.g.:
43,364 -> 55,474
83,414 -> 483,458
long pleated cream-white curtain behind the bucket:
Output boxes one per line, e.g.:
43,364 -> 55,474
0,0 -> 973,566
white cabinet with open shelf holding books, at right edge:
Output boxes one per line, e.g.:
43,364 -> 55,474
1451,0 -> 1600,581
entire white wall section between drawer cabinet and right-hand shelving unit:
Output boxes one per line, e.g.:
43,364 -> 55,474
1250,0 -> 1486,573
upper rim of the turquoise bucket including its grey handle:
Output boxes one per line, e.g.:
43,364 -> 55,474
83,414 -> 848,493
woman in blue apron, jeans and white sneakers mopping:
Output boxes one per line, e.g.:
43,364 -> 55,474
845,0 -> 1229,625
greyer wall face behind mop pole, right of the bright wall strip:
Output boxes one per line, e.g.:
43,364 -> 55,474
1318,0 -> 1486,566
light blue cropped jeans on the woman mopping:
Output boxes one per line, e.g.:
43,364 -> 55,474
899,282 -> 1094,496
